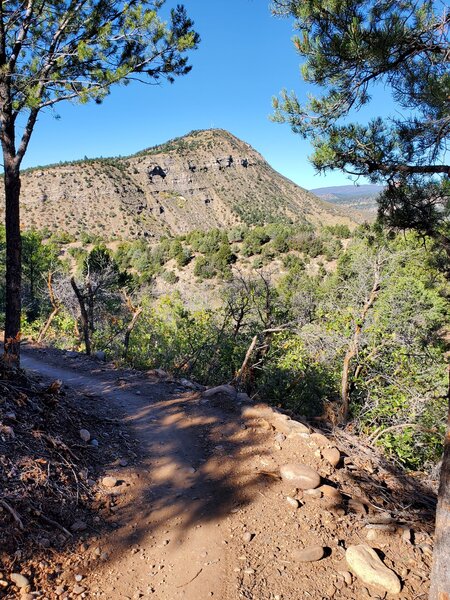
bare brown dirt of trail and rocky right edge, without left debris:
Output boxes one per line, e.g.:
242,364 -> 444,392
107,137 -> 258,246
0,348 -> 433,600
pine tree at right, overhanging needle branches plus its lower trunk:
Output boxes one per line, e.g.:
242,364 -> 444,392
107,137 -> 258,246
273,0 -> 450,600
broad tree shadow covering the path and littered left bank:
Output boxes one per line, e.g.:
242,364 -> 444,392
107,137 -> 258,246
5,351 -> 276,598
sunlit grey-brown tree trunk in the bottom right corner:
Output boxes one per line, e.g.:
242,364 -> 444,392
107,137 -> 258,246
429,370 -> 450,600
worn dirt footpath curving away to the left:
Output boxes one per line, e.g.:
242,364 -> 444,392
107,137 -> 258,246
22,349 -> 270,600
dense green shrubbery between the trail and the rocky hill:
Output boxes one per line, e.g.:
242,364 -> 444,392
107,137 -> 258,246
6,224 -> 448,468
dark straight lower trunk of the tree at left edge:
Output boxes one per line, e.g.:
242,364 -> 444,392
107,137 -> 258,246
3,162 -> 22,367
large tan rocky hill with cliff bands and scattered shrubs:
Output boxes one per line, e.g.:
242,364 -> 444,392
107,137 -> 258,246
1,129 -> 354,238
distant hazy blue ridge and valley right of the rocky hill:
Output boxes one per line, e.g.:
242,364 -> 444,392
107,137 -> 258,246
310,184 -> 384,217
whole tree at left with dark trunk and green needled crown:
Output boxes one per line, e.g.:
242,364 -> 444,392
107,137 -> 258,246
0,0 -> 199,364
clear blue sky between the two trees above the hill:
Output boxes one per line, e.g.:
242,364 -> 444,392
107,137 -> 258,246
19,0 -> 388,189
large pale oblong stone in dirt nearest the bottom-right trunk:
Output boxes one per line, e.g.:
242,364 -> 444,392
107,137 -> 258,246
345,544 -> 402,594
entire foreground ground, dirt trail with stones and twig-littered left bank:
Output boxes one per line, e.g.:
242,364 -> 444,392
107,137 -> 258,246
0,347 -> 435,600
